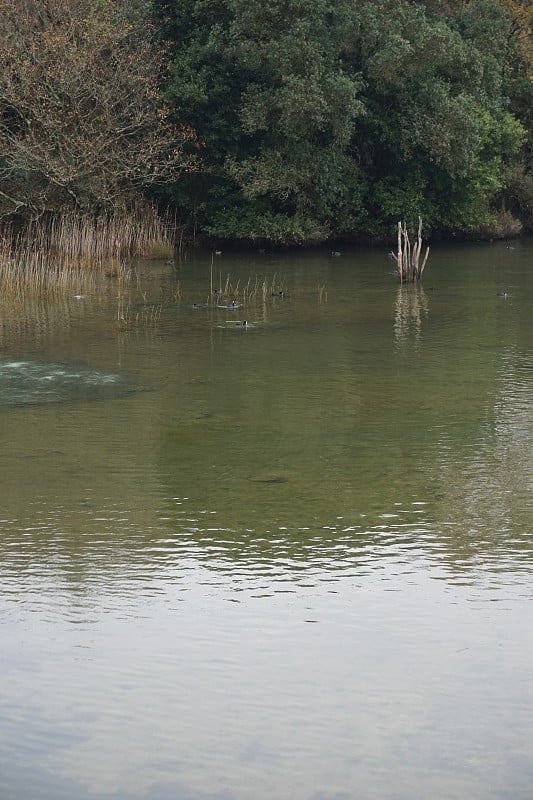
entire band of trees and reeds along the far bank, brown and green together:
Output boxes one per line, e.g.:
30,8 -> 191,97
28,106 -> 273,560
0,0 -> 533,282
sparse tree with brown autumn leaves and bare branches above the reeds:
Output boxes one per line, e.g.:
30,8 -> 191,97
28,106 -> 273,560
0,0 -> 193,215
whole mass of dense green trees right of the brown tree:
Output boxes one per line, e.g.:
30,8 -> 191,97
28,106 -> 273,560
154,0 -> 532,242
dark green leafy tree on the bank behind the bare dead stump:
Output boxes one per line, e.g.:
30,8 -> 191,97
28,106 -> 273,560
350,0 -> 524,232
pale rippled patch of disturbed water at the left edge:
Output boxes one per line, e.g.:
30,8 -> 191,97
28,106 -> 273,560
0,360 -> 134,408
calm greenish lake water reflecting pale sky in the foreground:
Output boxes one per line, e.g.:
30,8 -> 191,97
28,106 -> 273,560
0,240 -> 533,800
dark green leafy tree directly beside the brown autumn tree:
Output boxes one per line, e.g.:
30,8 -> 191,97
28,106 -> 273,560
152,0 -> 363,243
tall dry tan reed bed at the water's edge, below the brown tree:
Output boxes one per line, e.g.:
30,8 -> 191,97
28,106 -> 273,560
0,205 -> 175,297
